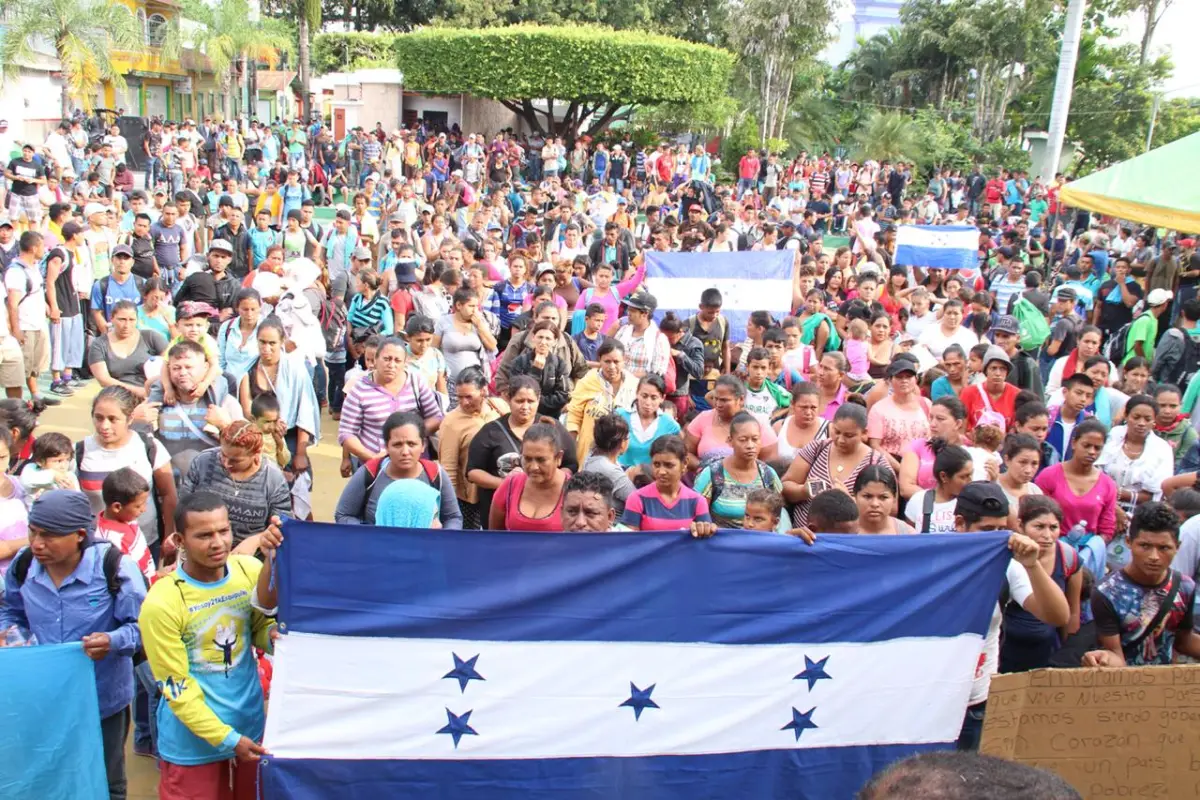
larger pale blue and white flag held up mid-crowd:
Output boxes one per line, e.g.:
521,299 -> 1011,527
646,249 -> 794,342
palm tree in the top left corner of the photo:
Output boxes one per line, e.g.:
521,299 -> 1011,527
0,0 -> 145,119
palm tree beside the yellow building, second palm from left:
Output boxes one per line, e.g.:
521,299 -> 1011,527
184,0 -> 293,120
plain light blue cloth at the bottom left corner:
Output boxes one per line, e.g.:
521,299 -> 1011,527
0,644 -> 108,800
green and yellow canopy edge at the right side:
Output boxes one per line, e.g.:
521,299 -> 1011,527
1058,133 -> 1200,231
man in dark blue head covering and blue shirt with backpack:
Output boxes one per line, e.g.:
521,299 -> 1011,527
0,489 -> 146,798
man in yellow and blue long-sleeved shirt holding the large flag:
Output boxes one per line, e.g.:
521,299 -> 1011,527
138,492 -> 275,800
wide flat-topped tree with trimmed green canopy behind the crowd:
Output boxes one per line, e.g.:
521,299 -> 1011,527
396,25 -> 733,138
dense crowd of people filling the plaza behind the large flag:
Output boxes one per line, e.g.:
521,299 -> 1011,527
0,113 -> 1200,798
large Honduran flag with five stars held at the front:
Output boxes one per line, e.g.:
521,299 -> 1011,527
262,523 -> 1009,800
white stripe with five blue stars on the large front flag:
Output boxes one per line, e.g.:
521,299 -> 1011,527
265,633 -> 982,759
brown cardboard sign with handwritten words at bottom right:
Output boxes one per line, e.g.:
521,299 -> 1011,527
980,664 -> 1200,800
